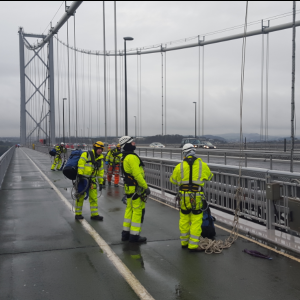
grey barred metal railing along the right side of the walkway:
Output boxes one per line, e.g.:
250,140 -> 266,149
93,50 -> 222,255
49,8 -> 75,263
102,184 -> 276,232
142,157 -> 300,233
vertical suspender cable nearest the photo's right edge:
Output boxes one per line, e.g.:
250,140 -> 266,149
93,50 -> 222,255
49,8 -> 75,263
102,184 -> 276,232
290,1 -> 296,172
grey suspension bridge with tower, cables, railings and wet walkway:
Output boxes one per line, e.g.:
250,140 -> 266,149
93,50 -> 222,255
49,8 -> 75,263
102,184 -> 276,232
0,1 -> 300,300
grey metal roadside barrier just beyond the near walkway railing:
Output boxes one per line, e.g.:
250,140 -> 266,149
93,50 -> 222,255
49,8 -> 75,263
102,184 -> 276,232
137,147 -> 300,170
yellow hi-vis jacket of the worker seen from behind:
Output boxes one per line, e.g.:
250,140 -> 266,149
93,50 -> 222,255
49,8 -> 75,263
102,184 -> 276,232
170,158 -> 213,186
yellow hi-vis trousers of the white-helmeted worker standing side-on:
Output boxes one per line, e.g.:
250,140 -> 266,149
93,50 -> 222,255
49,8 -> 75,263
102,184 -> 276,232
122,198 -> 146,241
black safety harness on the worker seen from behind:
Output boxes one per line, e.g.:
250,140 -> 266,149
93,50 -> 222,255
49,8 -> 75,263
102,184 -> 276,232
177,156 -> 208,215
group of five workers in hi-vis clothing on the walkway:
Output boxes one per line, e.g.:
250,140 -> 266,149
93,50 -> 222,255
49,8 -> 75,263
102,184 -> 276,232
51,136 -> 213,252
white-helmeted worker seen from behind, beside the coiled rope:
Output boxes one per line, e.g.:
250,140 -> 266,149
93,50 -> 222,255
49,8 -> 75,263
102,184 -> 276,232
170,144 -> 213,252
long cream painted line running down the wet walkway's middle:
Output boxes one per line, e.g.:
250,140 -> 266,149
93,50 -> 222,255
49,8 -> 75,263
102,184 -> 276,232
22,149 -> 154,300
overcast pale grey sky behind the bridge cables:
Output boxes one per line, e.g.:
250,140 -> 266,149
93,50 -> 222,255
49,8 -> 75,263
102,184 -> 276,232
0,1 -> 300,137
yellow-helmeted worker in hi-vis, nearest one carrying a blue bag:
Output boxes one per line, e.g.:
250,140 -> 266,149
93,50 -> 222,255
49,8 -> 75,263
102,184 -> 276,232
75,141 -> 104,221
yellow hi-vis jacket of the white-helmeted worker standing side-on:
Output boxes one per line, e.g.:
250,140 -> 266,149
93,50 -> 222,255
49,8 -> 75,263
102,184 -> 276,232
123,154 -> 148,194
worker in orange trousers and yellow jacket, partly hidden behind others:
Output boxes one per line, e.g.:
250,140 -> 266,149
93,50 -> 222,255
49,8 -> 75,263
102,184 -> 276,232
105,144 -> 122,187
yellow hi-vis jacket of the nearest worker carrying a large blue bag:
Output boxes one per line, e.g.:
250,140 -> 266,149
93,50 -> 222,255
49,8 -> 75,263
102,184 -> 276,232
77,149 -> 104,184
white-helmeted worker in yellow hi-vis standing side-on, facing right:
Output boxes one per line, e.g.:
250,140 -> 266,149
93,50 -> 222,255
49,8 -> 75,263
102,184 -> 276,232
119,136 -> 150,243
